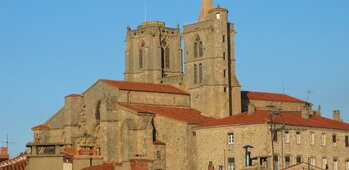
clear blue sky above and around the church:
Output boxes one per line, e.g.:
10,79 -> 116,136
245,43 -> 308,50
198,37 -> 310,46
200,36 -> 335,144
0,0 -> 349,156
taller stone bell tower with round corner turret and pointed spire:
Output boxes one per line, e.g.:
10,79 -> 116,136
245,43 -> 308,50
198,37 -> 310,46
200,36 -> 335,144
182,0 -> 241,118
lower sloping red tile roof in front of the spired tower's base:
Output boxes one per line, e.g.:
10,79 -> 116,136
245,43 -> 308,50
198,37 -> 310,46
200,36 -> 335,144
119,103 -> 213,124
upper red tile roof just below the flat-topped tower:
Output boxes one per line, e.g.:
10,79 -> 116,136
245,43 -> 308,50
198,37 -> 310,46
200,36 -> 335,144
101,80 -> 188,95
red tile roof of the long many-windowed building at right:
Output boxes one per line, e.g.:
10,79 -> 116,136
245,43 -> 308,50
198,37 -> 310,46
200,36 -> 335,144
198,110 -> 349,130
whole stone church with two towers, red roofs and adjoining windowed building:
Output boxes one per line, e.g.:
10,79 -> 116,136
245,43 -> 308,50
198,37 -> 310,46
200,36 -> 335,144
21,0 -> 349,170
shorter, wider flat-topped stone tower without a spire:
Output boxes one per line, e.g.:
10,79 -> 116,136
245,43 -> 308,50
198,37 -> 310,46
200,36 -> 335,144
124,21 -> 183,83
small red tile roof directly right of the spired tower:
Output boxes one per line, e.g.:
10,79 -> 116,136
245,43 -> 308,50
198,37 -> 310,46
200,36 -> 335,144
241,91 -> 306,103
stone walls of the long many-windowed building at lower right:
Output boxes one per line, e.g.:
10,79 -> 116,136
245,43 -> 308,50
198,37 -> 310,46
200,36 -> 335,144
195,123 -> 349,170
